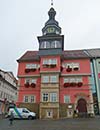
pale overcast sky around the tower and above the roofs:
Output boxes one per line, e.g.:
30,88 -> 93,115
0,0 -> 100,77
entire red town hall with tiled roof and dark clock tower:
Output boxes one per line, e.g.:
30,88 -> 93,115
17,7 -> 100,119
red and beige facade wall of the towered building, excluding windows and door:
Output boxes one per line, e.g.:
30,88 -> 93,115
18,56 -> 93,119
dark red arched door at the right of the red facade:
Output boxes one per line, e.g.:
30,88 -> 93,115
77,98 -> 87,113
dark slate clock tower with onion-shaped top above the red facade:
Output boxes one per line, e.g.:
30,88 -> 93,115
38,7 -> 64,56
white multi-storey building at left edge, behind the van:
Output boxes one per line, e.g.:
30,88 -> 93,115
0,70 -> 17,113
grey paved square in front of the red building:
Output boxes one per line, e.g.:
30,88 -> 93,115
0,117 -> 100,130
